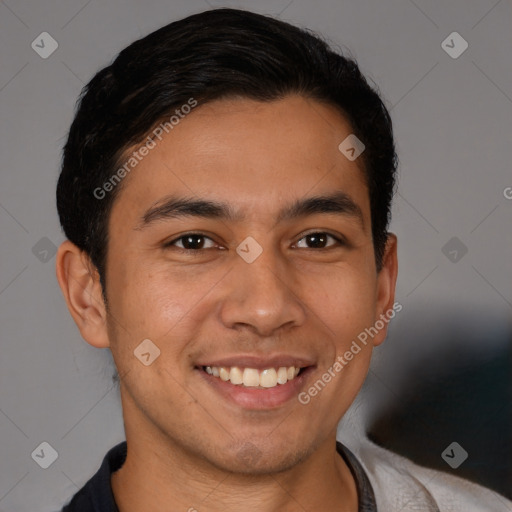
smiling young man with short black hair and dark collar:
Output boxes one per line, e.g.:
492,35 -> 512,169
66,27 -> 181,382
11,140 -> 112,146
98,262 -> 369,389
57,9 -> 510,512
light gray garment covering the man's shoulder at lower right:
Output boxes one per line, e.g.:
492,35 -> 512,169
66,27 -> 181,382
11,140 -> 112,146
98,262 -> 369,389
351,440 -> 512,512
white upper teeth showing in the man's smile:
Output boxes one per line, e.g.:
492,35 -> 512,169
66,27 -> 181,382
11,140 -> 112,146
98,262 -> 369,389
205,366 -> 300,388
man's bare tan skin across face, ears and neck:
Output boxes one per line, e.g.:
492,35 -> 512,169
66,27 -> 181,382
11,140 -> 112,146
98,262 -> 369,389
57,96 -> 397,512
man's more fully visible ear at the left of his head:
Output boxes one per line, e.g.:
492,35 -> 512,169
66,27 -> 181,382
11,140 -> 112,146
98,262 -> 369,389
56,240 -> 110,348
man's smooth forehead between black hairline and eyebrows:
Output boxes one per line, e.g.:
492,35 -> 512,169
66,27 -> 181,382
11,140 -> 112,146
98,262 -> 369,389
112,96 -> 369,224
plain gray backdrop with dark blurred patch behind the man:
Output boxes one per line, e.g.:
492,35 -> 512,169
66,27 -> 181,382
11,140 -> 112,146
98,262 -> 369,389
0,0 -> 512,512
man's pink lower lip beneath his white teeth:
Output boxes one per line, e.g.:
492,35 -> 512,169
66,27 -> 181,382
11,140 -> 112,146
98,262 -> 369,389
196,366 -> 314,410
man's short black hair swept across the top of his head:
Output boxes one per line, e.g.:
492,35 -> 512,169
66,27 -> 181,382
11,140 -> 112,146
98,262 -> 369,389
57,8 -> 397,298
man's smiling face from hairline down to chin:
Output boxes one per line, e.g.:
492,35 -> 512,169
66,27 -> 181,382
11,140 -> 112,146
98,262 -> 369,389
74,96 -> 396,473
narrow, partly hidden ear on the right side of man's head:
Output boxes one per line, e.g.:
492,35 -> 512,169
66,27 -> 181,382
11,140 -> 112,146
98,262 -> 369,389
373,233 -> 402,346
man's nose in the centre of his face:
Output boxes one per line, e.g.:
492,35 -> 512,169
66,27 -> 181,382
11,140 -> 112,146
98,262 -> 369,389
220,245 -> 306,337
